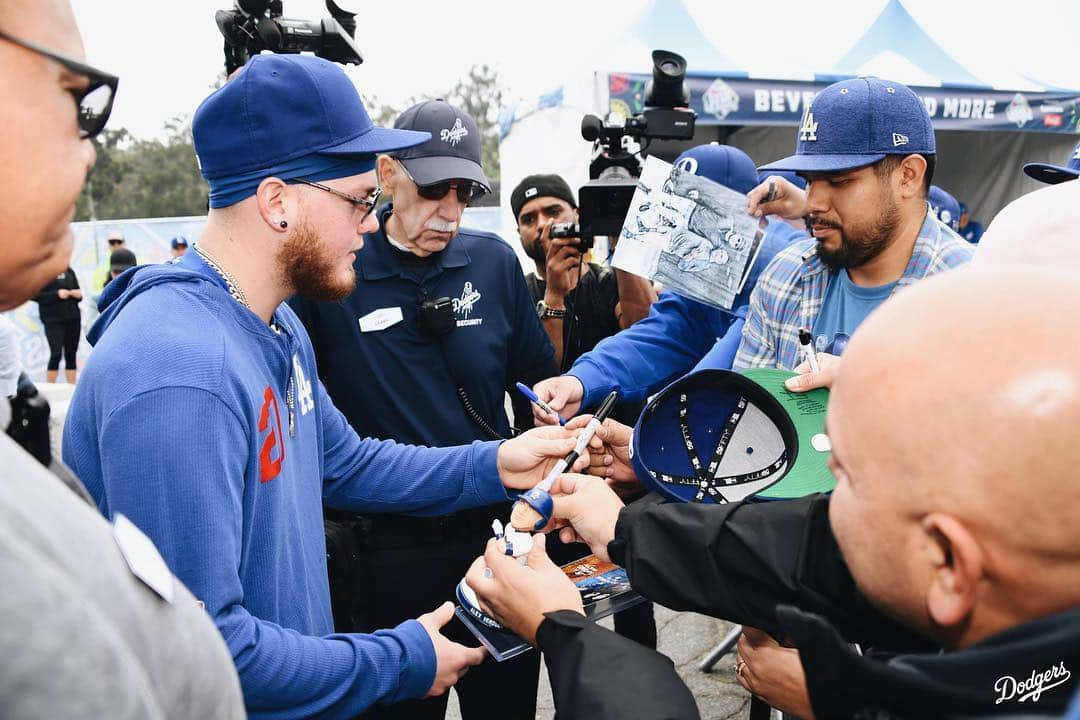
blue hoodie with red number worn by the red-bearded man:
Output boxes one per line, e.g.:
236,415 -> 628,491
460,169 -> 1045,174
64,252 -> 507,718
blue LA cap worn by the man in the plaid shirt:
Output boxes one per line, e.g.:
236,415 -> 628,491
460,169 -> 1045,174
760,78 -> 937,173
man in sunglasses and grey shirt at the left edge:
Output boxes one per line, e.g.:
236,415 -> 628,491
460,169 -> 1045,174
0,0 -> 244,719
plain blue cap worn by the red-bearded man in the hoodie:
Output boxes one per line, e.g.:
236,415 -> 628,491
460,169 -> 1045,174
191,55 -> 430,202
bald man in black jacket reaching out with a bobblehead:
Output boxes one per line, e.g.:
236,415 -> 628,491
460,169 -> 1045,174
468,268 -> 1080,718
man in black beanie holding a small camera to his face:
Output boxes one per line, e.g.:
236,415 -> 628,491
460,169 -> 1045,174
510,175 -> 657,370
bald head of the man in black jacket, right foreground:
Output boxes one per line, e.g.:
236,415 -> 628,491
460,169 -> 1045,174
828,268 -> 1080,644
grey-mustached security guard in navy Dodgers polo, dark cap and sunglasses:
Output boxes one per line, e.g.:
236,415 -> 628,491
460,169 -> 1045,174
294,100 -> 555,720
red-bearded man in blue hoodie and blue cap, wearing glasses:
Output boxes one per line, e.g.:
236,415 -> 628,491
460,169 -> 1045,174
64,55 -> 596,718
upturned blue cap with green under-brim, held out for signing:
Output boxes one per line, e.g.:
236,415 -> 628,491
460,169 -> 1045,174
631,368 -> 836,503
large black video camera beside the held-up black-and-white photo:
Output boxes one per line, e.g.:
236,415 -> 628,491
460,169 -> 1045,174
570,50 -> 697,249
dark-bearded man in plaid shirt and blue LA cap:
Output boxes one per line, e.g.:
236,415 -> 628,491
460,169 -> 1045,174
734,78 -> 972,369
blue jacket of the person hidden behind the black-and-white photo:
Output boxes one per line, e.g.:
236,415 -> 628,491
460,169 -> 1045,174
567,218 -> 807,408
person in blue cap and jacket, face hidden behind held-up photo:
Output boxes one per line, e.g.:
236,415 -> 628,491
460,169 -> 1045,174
534,145 -> 806,433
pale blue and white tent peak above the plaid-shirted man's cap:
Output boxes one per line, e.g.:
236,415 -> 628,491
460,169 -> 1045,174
816,0 -> 988,87
